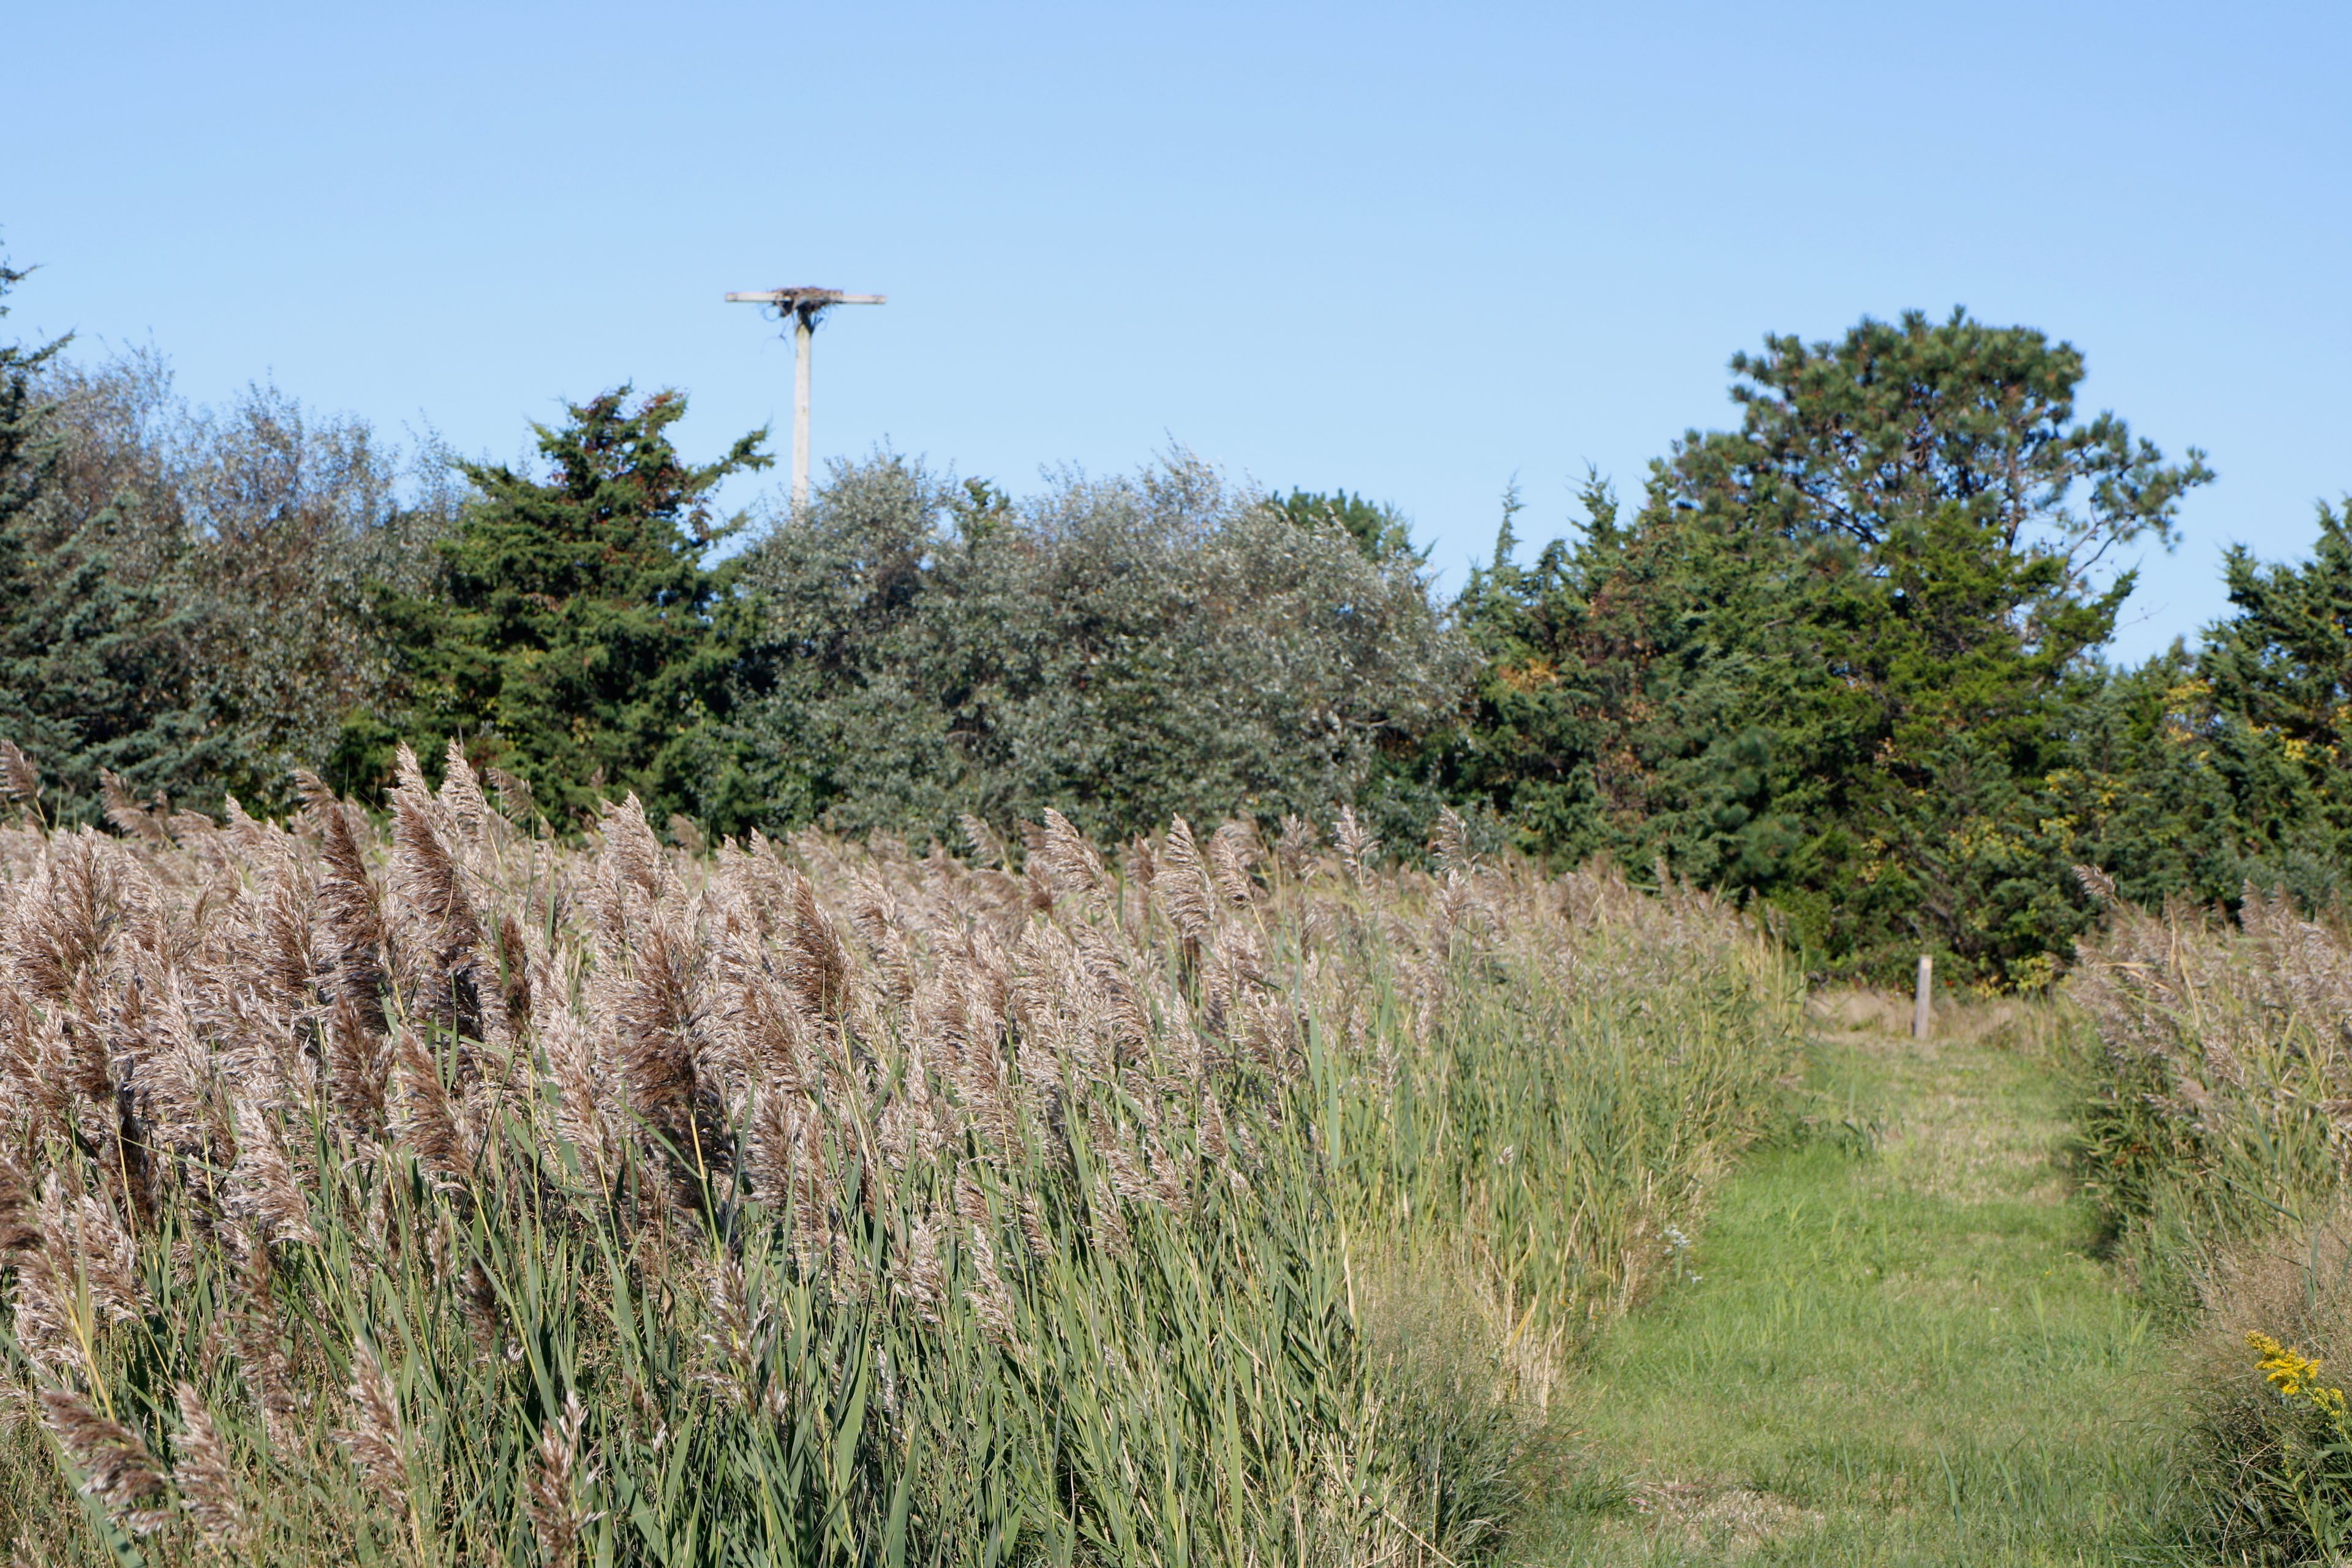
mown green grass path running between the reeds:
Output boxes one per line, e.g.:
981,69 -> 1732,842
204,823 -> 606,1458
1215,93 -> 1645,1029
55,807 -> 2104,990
1526,999 -> 2164,1563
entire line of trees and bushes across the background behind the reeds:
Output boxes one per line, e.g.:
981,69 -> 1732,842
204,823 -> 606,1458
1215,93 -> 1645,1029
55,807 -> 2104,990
0,268 -> 2352,985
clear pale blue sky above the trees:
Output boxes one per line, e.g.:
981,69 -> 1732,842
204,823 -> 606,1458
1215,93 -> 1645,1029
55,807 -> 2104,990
0,0 -> 2352,656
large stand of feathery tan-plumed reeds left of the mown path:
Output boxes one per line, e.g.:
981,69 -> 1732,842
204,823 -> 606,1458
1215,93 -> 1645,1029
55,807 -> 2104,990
0,755 -> 1790,1566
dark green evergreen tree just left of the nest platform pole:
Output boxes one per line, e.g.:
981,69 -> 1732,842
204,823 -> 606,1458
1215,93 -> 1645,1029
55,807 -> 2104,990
360,388 -> 769,827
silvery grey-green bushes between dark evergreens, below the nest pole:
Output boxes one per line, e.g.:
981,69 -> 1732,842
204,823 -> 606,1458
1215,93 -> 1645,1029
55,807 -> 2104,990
736,454 -> 1470,842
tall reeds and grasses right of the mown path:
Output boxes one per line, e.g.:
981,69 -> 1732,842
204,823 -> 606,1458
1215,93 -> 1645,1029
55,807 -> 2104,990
2070,875 -> 2352,1563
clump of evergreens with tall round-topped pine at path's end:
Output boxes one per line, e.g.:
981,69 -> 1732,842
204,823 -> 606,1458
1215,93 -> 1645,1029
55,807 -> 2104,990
1458,312 -> 2211,978
